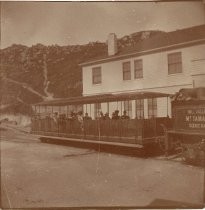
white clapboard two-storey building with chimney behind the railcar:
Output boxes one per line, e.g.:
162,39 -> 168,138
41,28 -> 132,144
80,25 -> 205,118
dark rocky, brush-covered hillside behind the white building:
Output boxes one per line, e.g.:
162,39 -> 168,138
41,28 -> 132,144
0,31 -> 162,113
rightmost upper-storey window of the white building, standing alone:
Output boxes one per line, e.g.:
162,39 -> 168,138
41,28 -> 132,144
168,52 -> 182,74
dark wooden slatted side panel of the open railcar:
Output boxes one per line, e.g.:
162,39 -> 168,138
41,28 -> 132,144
32,117 -> 171,144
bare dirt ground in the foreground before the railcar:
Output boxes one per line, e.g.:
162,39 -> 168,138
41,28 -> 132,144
1,126 -> 204,208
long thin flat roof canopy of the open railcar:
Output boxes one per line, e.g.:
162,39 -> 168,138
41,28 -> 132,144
34,92 -> 170,106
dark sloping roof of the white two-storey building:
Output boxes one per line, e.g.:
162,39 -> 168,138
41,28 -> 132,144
80,24 -> 205,66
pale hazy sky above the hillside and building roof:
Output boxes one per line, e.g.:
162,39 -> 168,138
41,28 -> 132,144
1,1 -> 205,48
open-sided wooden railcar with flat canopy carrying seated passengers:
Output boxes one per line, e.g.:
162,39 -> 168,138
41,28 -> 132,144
32,92 -> 171,147
